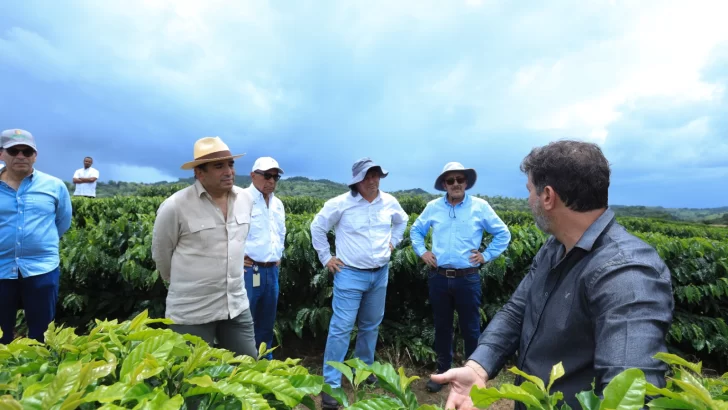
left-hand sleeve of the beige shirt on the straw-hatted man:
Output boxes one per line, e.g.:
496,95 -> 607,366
152,200 -> 180,281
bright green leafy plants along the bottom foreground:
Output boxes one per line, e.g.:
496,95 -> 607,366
0,311 -> 728,410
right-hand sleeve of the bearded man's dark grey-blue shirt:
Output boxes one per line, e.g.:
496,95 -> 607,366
588,264 -> 674,391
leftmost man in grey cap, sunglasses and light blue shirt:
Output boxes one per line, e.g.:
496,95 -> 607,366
0,129 -> 72,344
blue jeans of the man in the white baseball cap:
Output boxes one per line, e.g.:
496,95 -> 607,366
245,266 -> 279,360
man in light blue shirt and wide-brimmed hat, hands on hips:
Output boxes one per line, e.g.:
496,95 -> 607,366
410,162 -> 511,392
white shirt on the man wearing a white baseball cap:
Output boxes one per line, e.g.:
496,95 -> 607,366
245,184 -> 286,262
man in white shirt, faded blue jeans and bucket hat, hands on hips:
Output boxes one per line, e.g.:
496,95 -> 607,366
311,158 -> 408,408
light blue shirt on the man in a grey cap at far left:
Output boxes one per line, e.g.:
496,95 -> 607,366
0,170 -> 71,279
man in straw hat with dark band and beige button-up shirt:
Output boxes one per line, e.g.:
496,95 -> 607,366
152,137 -> 257,358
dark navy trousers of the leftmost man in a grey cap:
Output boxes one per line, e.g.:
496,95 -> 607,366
0,268 -> 61,344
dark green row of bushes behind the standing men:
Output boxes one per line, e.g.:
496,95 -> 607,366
52,197 -> 728,369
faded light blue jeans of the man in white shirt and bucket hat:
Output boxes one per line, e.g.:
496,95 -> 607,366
324,265 -> 389,388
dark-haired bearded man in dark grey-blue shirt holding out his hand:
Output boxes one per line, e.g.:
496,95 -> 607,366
432,141 -> 674,409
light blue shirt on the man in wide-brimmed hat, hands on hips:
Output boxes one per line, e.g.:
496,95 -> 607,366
410,194 -> 511,269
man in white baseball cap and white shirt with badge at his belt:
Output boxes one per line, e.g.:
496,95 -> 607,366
244,157 -> 286,360
